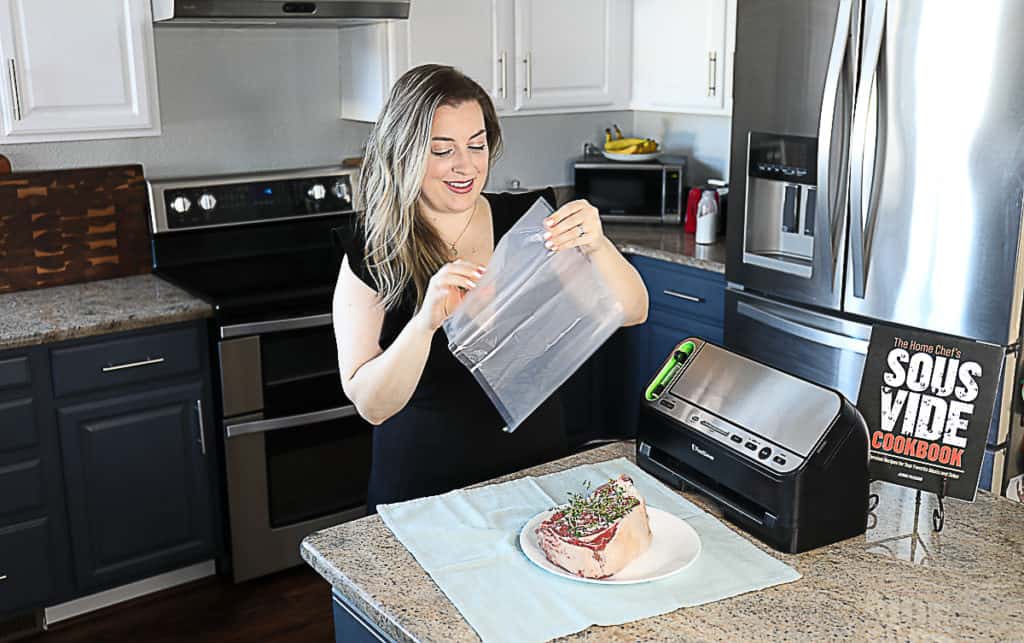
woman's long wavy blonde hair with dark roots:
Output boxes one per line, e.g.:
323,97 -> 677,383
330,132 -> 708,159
358,65 -> 502,309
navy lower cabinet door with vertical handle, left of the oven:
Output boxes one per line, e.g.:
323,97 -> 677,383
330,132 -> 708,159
57,379 -> 215,593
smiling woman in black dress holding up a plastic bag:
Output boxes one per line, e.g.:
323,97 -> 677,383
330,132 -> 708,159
334,65 -> 647,511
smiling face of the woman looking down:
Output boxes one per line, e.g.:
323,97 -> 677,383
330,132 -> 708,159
420,100 -> 489,213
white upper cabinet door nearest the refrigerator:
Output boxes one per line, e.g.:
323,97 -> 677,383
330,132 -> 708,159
632,0 -> 736,114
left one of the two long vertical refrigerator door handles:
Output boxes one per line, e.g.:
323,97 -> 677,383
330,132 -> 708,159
814,0 -> 854,283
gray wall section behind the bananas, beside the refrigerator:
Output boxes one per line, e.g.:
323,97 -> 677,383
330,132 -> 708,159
633,112 -> 732,185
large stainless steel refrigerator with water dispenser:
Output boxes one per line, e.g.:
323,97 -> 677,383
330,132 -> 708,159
725,0 -> 1024,491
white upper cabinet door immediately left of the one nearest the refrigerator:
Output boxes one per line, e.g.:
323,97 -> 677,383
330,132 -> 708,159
515,0 -> 632,110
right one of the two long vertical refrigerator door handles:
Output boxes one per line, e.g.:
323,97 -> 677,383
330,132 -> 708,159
850,0 -> 887,299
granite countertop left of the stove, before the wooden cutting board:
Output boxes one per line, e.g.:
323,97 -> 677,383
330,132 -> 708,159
0,274 -> 213,350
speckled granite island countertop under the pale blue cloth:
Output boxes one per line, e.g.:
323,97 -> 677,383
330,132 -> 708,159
302,442 -> 1024,641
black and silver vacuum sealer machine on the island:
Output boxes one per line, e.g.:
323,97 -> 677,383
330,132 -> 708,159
636,338 -> 868,553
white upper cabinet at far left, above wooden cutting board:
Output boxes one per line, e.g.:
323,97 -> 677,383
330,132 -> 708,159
0,0 -> 160,142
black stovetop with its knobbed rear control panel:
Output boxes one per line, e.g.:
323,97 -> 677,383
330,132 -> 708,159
150,168 -> 357,326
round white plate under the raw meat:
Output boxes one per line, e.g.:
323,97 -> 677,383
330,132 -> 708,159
519,507 -> 700,585
